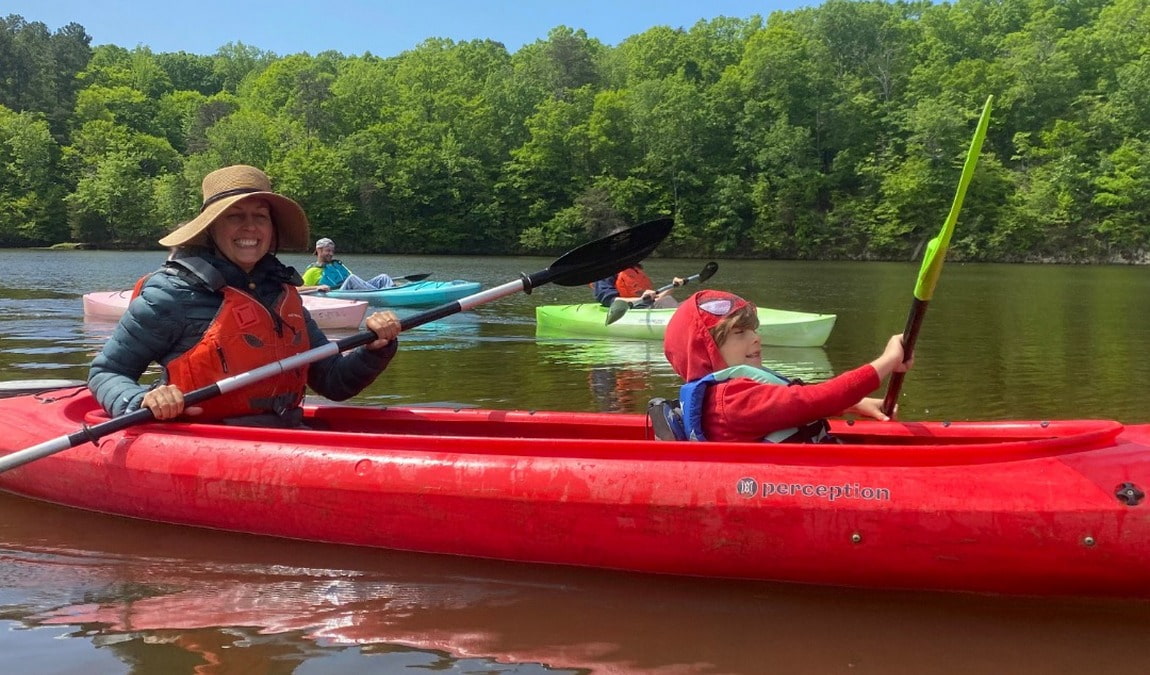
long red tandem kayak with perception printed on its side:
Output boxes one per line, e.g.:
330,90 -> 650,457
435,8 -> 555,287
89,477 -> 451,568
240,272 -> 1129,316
0,388 -> 1150,598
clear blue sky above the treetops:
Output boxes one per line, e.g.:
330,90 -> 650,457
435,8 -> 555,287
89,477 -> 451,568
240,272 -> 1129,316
8,0 -> 821,56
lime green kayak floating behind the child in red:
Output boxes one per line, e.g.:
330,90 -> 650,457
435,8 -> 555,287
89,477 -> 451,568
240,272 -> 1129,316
535,302 -> 836,347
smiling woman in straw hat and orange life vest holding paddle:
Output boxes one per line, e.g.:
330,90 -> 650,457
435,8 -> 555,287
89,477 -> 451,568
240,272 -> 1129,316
90,166 -> 400,427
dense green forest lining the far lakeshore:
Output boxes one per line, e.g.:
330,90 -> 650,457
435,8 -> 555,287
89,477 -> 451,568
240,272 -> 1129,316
0,0 -> 1150,262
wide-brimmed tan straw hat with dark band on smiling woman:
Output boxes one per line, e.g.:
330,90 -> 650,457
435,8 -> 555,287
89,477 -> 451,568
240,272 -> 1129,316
160,164 -> 311,251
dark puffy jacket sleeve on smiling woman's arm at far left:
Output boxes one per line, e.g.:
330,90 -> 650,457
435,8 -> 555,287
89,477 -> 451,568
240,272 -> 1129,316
87,279 -> 186,416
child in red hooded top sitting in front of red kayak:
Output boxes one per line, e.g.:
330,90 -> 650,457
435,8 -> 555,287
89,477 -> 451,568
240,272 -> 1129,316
664,290 -> 913,443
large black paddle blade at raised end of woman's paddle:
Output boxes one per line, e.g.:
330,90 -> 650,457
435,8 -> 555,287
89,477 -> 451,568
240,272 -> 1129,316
529,218 -> 675,289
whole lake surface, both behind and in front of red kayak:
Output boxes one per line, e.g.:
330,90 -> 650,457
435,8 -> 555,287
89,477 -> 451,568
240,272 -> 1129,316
0,251 -> 1150,675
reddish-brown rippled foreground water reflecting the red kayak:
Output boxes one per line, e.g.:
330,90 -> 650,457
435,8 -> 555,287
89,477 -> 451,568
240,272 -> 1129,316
0,496 -> 1147,675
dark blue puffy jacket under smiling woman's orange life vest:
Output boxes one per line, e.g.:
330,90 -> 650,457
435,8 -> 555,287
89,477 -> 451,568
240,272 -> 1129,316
87,251 -> 398,416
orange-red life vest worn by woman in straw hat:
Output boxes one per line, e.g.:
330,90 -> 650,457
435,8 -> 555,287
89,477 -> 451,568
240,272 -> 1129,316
167,284 -> 308,422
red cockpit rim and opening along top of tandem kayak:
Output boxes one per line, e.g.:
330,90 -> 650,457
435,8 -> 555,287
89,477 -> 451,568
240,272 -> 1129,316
65,404 -> 1125,466
